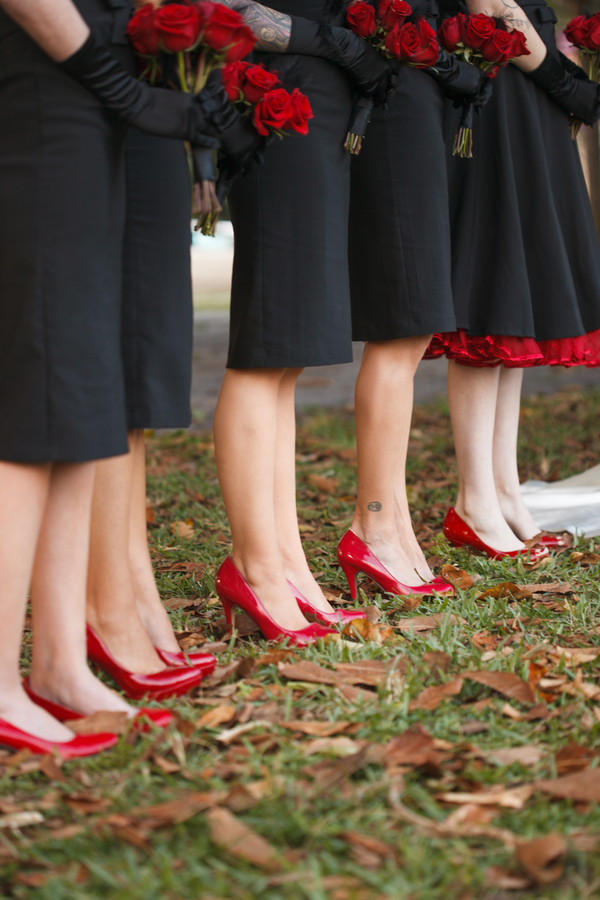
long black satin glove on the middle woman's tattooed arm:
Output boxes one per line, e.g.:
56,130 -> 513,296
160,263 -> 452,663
286,16 -> 397,103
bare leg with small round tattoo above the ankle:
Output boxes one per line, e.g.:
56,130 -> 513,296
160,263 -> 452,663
352,335 -> 433,585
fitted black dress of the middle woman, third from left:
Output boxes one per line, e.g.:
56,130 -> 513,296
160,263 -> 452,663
227,0 -> 352,369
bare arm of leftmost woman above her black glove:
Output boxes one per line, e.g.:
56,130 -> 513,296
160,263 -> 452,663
0,0 -> 90,62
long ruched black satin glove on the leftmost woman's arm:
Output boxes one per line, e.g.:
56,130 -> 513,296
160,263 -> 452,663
60,35 -> 219,147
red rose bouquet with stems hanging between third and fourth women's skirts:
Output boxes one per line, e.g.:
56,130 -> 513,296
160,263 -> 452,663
344,0 -> 439,155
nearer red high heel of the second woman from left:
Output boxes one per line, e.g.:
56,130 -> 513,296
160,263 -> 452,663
87,625 -> 203,700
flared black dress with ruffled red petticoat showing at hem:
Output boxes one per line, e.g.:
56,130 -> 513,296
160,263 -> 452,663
429,0 -> 600,367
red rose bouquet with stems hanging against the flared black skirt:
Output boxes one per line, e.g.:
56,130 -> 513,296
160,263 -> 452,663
438,13 -> 529,157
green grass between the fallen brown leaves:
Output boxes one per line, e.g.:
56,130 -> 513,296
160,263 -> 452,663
0,389 -> 600,900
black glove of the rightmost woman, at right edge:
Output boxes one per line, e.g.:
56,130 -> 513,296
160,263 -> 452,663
525,52 -> 600,125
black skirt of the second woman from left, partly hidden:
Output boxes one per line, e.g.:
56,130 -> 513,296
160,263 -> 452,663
122,129 -> 193,428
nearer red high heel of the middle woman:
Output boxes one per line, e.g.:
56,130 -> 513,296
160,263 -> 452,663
215,557 -> 337,647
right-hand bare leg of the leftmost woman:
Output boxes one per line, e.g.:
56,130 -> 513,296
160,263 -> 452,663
31,463 -> 133,715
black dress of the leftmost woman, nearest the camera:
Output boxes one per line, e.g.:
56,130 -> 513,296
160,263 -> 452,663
0,0 -> 133,462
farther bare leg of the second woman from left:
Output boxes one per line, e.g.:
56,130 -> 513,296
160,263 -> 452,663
129,429 -> 179,653
